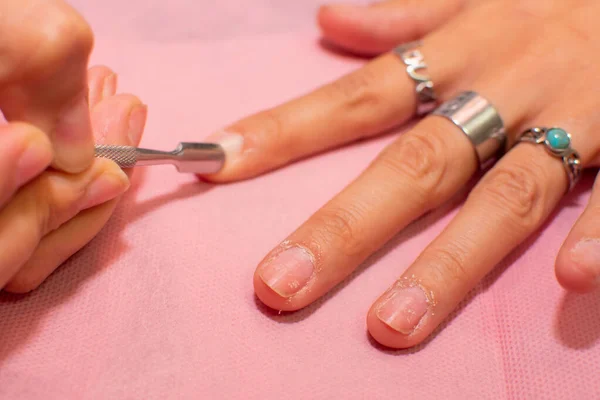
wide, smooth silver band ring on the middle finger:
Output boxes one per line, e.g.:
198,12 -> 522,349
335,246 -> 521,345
432,91 -> 507,169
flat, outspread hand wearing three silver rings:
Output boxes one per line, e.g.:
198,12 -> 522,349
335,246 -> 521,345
200,0 -> 600,348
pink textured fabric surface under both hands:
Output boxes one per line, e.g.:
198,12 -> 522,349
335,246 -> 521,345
0,0 -> 600,399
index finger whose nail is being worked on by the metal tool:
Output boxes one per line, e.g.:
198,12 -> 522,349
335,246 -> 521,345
204,38 -> 468,182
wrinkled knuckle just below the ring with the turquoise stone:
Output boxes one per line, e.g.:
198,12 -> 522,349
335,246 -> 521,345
480,162 -> 545,229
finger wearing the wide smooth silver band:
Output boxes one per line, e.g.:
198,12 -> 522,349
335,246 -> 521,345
254,71 -> 526,310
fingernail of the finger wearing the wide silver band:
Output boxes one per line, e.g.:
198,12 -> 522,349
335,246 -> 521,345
259,247 -> 314,297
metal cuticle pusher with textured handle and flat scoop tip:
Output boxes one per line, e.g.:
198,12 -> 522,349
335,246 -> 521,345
95,143 -> 225,174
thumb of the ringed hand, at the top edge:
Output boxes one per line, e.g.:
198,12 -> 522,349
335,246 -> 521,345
318,0 -> 466,55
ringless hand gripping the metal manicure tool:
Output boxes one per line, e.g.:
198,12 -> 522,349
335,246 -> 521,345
0,0 -> 146,292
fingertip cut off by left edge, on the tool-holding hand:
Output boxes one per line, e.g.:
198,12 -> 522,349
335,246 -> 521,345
0,123 -> 52,209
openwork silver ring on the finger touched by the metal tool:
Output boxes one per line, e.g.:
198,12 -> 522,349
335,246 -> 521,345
393,41 -> 437,116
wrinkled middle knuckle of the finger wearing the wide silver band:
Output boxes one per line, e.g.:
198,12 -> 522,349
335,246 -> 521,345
379,134 -> 447,196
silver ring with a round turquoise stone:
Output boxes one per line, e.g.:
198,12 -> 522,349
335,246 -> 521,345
518,127 -> 583,191
